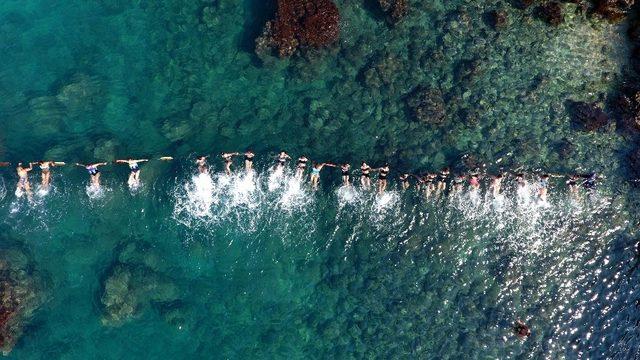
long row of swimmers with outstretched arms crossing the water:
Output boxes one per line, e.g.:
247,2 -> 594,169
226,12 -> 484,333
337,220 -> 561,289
0,150 -> 599,200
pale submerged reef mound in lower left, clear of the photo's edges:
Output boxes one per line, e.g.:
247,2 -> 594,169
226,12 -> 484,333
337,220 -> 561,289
100,242 -> 179,326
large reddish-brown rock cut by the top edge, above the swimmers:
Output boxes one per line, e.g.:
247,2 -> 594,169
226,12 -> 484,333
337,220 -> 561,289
256,0 -> 340,58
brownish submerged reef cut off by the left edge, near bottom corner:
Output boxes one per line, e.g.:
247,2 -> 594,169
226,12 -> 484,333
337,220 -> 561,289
0,248 -> 44,355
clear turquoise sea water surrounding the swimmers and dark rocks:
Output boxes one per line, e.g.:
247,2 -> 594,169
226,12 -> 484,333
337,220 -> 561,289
0,0 -> 640,359
